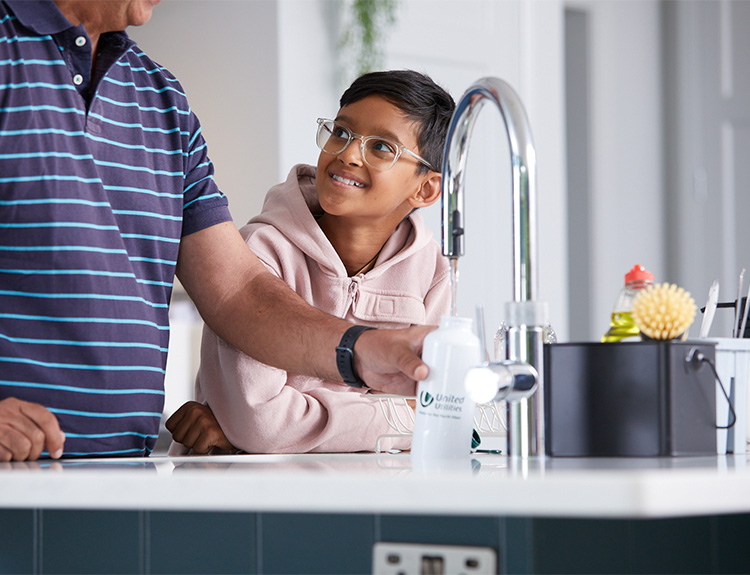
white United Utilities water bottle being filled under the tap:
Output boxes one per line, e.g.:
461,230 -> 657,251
411,316 -> 482,469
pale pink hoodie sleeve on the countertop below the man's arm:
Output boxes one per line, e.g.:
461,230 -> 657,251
197,328 -> 411,453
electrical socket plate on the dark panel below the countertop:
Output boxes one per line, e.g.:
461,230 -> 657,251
372,541 -> 497,575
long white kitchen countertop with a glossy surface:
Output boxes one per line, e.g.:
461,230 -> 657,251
0,453 -> 750,518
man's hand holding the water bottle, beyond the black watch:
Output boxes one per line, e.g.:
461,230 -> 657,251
354,325 -> 436,396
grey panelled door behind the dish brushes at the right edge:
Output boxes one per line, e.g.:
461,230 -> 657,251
663,0 -> 750,337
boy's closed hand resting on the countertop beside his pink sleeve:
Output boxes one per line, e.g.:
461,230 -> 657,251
164,401 -> 237,454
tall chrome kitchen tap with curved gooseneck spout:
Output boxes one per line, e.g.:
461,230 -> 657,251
442,78 -> 547,457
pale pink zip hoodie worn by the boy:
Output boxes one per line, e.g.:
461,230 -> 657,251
170,165 -> 450,455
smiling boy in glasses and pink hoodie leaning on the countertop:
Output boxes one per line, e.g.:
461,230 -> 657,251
167,70 -> 454,454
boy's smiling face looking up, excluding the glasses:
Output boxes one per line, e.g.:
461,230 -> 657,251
316,95 -> 439,229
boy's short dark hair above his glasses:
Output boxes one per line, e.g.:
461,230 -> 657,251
339,70 -> 456,173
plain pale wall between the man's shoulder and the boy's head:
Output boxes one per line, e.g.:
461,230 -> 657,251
128,0 -> 282,226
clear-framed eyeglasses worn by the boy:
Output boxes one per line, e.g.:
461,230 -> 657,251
315,118 -> 435,172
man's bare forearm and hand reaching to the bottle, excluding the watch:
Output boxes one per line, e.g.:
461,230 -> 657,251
177,222 -> 432,395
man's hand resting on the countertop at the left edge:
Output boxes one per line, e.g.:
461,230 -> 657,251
0,397 -> 65,461
